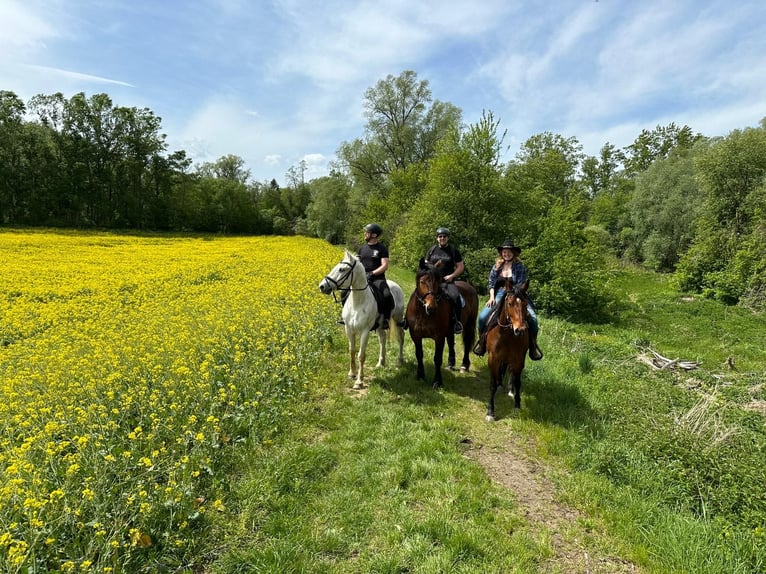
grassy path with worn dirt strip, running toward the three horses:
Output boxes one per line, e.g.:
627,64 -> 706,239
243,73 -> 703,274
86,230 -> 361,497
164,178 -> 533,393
208,340 -> 637,573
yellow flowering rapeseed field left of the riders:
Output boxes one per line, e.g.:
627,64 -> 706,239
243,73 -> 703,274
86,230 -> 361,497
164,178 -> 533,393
0,230 -> 340,572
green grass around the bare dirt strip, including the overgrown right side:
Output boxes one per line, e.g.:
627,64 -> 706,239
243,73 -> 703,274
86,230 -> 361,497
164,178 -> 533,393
209,262 -> 766,574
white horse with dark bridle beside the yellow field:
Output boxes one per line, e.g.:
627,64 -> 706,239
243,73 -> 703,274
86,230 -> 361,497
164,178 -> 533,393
319,249 -> 404,389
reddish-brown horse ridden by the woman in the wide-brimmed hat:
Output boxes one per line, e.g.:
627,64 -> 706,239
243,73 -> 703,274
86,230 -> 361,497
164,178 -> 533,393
487,284 -> 529,421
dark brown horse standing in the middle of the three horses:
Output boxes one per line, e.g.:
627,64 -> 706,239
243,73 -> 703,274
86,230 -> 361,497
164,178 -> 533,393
406,259 -> 479,388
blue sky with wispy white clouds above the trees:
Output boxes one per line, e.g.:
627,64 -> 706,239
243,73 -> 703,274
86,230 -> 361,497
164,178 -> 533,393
0,0 -> 766,183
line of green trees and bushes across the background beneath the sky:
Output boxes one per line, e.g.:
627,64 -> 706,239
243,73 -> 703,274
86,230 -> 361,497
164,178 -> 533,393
0,71 -> 766,320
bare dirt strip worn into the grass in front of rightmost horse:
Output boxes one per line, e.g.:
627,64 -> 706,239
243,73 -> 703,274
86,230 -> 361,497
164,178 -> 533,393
465,429 -> 640,574
